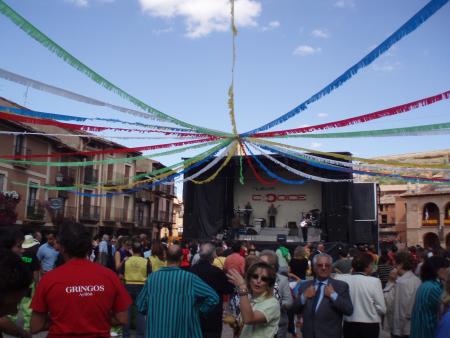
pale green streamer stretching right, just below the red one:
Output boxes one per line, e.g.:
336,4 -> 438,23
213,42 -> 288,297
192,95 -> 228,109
275,122 -> 450,138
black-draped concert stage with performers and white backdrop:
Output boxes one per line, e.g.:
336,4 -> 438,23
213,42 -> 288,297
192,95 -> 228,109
183,153 -> 378,244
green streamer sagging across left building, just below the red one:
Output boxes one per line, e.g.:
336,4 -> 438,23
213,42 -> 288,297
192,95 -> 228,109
0,140 -> 225,167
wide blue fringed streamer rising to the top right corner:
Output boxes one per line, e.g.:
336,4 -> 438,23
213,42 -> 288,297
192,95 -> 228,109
241,0 -> 449,136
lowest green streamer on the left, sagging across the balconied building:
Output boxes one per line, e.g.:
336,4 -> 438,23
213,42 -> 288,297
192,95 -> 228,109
12,139 -> 231,191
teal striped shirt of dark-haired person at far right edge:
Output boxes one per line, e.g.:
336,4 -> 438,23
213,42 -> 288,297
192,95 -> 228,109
410,280 -> 442,338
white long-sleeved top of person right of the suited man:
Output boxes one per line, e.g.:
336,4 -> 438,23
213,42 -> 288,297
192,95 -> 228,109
335,274 -> 386,323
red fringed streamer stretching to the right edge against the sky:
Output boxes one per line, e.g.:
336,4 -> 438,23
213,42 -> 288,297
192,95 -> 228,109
250,91 -> 450,137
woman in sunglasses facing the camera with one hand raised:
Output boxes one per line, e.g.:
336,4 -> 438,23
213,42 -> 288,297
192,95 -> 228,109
227,262 -> 280,338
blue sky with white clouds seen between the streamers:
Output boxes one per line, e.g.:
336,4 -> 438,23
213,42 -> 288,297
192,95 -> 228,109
0,0 -> 450,164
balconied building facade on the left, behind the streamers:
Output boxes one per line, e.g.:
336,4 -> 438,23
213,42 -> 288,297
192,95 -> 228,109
0,98 -> 176,238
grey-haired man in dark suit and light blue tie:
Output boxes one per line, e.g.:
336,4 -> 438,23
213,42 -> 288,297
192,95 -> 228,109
293,253 -> 353,338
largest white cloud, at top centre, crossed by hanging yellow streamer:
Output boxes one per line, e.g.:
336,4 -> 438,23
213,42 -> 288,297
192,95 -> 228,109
139,0 -> 261,38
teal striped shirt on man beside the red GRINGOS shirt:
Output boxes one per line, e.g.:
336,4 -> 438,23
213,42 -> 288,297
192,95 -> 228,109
137,267 -> 219,338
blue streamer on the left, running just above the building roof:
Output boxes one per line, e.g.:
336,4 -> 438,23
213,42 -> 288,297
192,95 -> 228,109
0,106 -> 192,132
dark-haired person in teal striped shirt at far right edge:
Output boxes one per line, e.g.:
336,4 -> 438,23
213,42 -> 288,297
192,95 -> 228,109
410,256 -> 450,338
